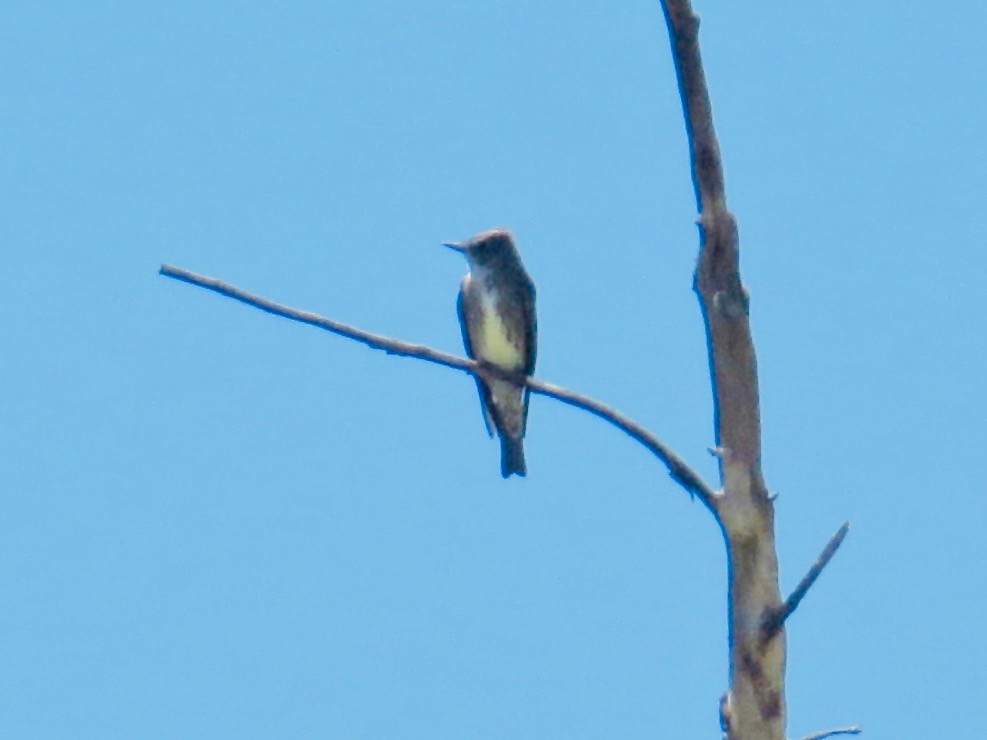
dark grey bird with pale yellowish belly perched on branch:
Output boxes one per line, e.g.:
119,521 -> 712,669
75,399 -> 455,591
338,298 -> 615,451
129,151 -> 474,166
445,229 -> 538,478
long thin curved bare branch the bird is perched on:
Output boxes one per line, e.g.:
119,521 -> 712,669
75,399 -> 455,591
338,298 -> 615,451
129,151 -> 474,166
159,265 -> 719,515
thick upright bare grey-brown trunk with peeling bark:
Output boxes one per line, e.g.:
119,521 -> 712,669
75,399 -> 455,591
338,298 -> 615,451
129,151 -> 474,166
662,0 -> 785,740
